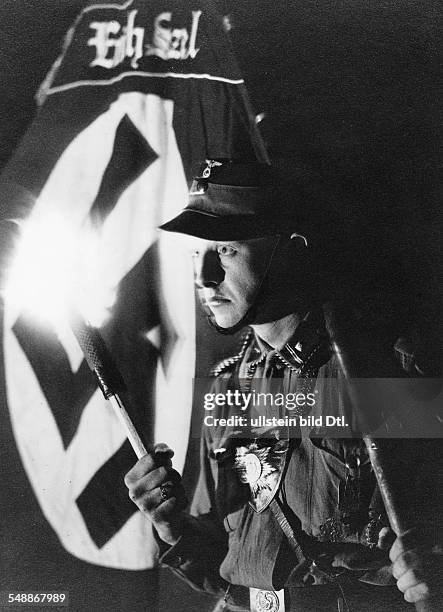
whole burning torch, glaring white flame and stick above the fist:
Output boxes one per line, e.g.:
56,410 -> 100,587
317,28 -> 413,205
4,212 -> 147,458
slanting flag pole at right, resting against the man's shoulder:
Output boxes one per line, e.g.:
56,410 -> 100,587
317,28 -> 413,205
324,303 -> 440,612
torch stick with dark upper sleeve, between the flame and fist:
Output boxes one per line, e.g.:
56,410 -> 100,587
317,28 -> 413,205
70,312 -> 147,459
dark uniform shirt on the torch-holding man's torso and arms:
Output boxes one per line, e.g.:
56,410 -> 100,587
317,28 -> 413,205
162,314 -> 442,604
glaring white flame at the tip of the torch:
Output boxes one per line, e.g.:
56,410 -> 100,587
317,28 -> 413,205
5,206 -> 116,330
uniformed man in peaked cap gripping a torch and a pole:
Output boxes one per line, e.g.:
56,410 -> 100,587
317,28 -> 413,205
126,160 -> 441,612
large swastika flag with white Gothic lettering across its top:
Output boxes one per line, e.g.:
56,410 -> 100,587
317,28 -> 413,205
1,0 -> 264,570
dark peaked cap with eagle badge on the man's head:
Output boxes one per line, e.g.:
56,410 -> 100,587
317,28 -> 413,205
160,160 -> 294,240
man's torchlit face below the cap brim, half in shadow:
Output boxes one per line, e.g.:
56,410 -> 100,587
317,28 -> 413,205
187,236 -> 278,328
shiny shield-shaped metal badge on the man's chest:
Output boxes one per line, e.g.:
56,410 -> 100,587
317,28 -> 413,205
235,440 -> 289,512
